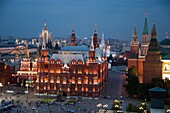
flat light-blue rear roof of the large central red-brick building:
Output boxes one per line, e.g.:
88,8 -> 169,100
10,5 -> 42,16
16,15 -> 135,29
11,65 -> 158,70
61,45 -> 90,51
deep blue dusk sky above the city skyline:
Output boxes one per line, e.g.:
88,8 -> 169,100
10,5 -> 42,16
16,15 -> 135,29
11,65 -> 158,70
0,0 -> 170,41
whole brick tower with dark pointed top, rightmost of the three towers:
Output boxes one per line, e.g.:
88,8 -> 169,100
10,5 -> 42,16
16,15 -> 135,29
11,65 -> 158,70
143,24 -> 162,84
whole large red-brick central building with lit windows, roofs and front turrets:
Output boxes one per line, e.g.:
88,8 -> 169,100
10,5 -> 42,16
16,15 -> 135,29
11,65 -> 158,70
34,30 -> 108,98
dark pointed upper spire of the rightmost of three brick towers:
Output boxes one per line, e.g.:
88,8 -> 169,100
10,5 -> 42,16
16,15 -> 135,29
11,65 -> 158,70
148,23 -> 159,51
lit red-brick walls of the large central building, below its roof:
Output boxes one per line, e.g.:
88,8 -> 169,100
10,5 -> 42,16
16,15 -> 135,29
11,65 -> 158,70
35,60 -> 108,97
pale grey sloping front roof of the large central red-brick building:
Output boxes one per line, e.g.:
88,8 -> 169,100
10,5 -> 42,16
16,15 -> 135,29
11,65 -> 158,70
51,54 -> 85,64
